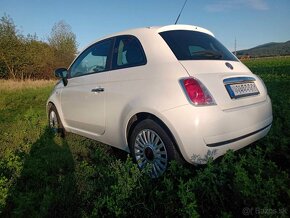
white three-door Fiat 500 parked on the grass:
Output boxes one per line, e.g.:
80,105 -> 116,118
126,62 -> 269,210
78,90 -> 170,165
47,25 -> 272,177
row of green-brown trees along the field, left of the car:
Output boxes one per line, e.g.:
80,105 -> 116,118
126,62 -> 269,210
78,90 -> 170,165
0,15 -> 77,80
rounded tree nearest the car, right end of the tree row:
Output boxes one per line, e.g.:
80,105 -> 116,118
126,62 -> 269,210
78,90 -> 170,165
48,20 -> 77,67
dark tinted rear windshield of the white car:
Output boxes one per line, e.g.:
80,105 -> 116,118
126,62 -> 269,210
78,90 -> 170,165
160,30 -> 237,61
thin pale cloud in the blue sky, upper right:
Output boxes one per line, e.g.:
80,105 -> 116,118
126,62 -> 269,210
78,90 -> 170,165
205,0 -> 269,12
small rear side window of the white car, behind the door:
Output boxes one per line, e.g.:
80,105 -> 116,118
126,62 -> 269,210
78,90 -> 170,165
113,35 -> 146,68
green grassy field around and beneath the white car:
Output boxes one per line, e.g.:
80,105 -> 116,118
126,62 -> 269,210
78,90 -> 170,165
0,57 -> 290,217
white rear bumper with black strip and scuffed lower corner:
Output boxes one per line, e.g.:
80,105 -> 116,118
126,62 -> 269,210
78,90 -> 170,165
163,96 -> 273,164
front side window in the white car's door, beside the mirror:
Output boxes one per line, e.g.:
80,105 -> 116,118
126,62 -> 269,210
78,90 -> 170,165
70,39 -> 112,77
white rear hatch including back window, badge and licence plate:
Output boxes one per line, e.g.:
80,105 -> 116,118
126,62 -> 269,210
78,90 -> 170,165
159,26 -> 267,110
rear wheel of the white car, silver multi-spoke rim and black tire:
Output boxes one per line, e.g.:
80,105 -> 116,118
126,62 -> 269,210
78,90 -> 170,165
129,119 -> 180,178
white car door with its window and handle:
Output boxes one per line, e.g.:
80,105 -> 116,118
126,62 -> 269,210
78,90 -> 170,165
61,38 -> 113,135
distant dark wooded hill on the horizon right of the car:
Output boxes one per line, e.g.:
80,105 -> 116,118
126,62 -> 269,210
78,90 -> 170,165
237,40 -> 290,57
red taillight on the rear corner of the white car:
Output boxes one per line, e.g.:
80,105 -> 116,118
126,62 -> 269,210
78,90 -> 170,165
181,77 -> 215,105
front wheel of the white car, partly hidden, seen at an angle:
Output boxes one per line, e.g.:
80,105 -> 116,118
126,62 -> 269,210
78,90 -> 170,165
48,104 -> 65,138
